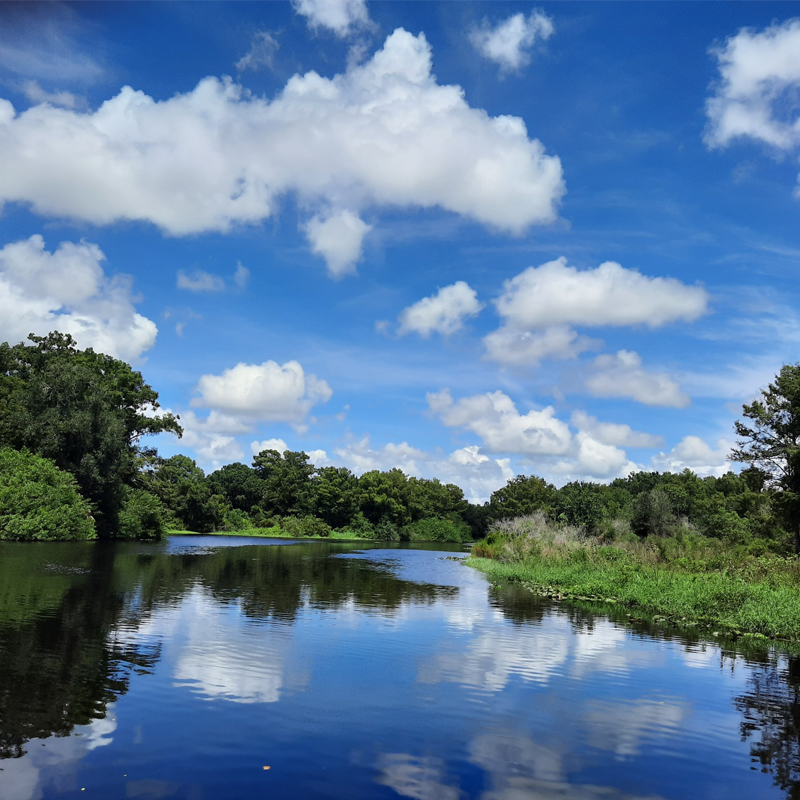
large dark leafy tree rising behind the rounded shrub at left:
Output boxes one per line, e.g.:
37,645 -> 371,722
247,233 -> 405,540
0,332 -> 183,536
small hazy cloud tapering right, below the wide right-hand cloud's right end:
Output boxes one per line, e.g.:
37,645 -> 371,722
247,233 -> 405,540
586,350 -> 692,408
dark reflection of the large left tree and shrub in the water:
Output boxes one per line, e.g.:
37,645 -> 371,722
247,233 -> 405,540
0,545 -> 158,758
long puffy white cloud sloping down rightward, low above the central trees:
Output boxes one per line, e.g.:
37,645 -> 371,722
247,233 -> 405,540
427,389 -> 572,455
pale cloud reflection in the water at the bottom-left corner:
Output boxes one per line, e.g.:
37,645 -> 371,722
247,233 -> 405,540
0,703 -> 117,800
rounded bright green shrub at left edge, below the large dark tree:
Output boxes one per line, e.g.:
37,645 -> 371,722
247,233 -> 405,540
0,447 -> 96,541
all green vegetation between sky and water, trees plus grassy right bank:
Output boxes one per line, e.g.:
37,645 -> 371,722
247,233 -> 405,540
0,332 -> 800,641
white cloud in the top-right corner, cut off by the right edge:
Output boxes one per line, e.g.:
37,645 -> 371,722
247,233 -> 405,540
705,19 -> 800,150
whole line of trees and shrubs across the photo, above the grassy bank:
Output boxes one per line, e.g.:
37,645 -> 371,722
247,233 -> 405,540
0,333 -> 800,551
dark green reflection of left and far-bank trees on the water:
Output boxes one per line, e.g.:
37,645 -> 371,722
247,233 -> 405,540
0,543 -> 457,758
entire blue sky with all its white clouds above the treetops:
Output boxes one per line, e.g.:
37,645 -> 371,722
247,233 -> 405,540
0,0 -> 800,499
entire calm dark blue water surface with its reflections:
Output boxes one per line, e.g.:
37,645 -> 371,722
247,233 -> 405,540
0,537 -> 800,800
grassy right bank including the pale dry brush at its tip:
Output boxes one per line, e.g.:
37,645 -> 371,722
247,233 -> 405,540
467,521 -> 800,642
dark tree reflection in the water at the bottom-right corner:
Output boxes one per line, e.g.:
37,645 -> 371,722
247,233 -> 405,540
734,656 -> 800,800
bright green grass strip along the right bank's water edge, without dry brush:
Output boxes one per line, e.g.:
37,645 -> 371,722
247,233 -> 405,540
466,548 -> 800,642
